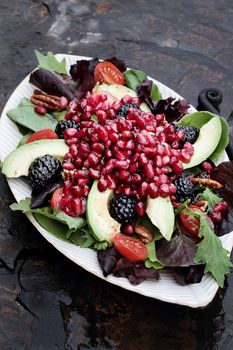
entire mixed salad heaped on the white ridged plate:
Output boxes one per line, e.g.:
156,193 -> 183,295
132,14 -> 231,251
0,52 -> 233,301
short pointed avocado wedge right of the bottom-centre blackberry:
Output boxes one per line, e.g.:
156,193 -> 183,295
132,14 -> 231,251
146,196 -> 175,241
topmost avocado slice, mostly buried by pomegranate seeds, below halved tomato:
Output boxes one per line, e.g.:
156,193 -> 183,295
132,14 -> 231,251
93,84 -> 150,112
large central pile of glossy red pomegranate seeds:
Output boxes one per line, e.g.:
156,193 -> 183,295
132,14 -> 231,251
59,93 -> 193,216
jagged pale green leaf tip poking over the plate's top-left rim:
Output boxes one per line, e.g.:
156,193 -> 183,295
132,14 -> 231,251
35,50 -> 67,74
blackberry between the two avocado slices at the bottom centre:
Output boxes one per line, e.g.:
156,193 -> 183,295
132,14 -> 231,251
109,194 -> 136,224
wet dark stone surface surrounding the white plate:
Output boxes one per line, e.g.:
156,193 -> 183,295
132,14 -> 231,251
0,0 -> 233,350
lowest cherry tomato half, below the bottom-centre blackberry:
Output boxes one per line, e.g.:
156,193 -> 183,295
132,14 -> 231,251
113,233 -> 148,261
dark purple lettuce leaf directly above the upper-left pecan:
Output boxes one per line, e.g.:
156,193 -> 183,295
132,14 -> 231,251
29,68 -> 75,101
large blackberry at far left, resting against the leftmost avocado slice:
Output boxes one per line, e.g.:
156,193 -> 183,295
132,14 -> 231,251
28,154 -> 62,190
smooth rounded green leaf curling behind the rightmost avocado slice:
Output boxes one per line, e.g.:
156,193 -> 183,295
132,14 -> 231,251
177,111 -> 229,161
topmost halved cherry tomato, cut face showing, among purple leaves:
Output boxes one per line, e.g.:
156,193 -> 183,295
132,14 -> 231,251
94,61 -> 125,85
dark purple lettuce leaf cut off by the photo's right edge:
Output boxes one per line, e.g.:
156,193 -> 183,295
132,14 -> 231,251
210,161 -> 233,236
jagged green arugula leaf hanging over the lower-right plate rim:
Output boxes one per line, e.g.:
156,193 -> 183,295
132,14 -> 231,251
186,209 -> 233,288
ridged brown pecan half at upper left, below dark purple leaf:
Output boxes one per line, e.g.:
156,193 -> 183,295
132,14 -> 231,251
30,90 -> 68,111
